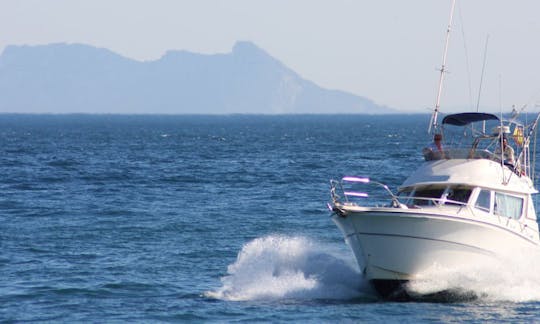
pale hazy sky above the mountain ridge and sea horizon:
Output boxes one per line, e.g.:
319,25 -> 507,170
0,0 -> 540,111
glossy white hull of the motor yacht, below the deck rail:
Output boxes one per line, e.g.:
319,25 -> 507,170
333,208 -> 538,297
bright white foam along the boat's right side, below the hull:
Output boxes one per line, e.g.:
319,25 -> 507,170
408,249 -> 540,302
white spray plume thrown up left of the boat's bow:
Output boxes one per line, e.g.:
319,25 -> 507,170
206,235 -> 370,301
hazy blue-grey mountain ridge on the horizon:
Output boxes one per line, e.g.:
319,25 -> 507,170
0,42 -> 393,114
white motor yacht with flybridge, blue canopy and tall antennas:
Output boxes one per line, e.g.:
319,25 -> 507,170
328,3 -> 540,300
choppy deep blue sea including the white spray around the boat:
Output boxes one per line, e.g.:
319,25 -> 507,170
0,114 -> 540,323
